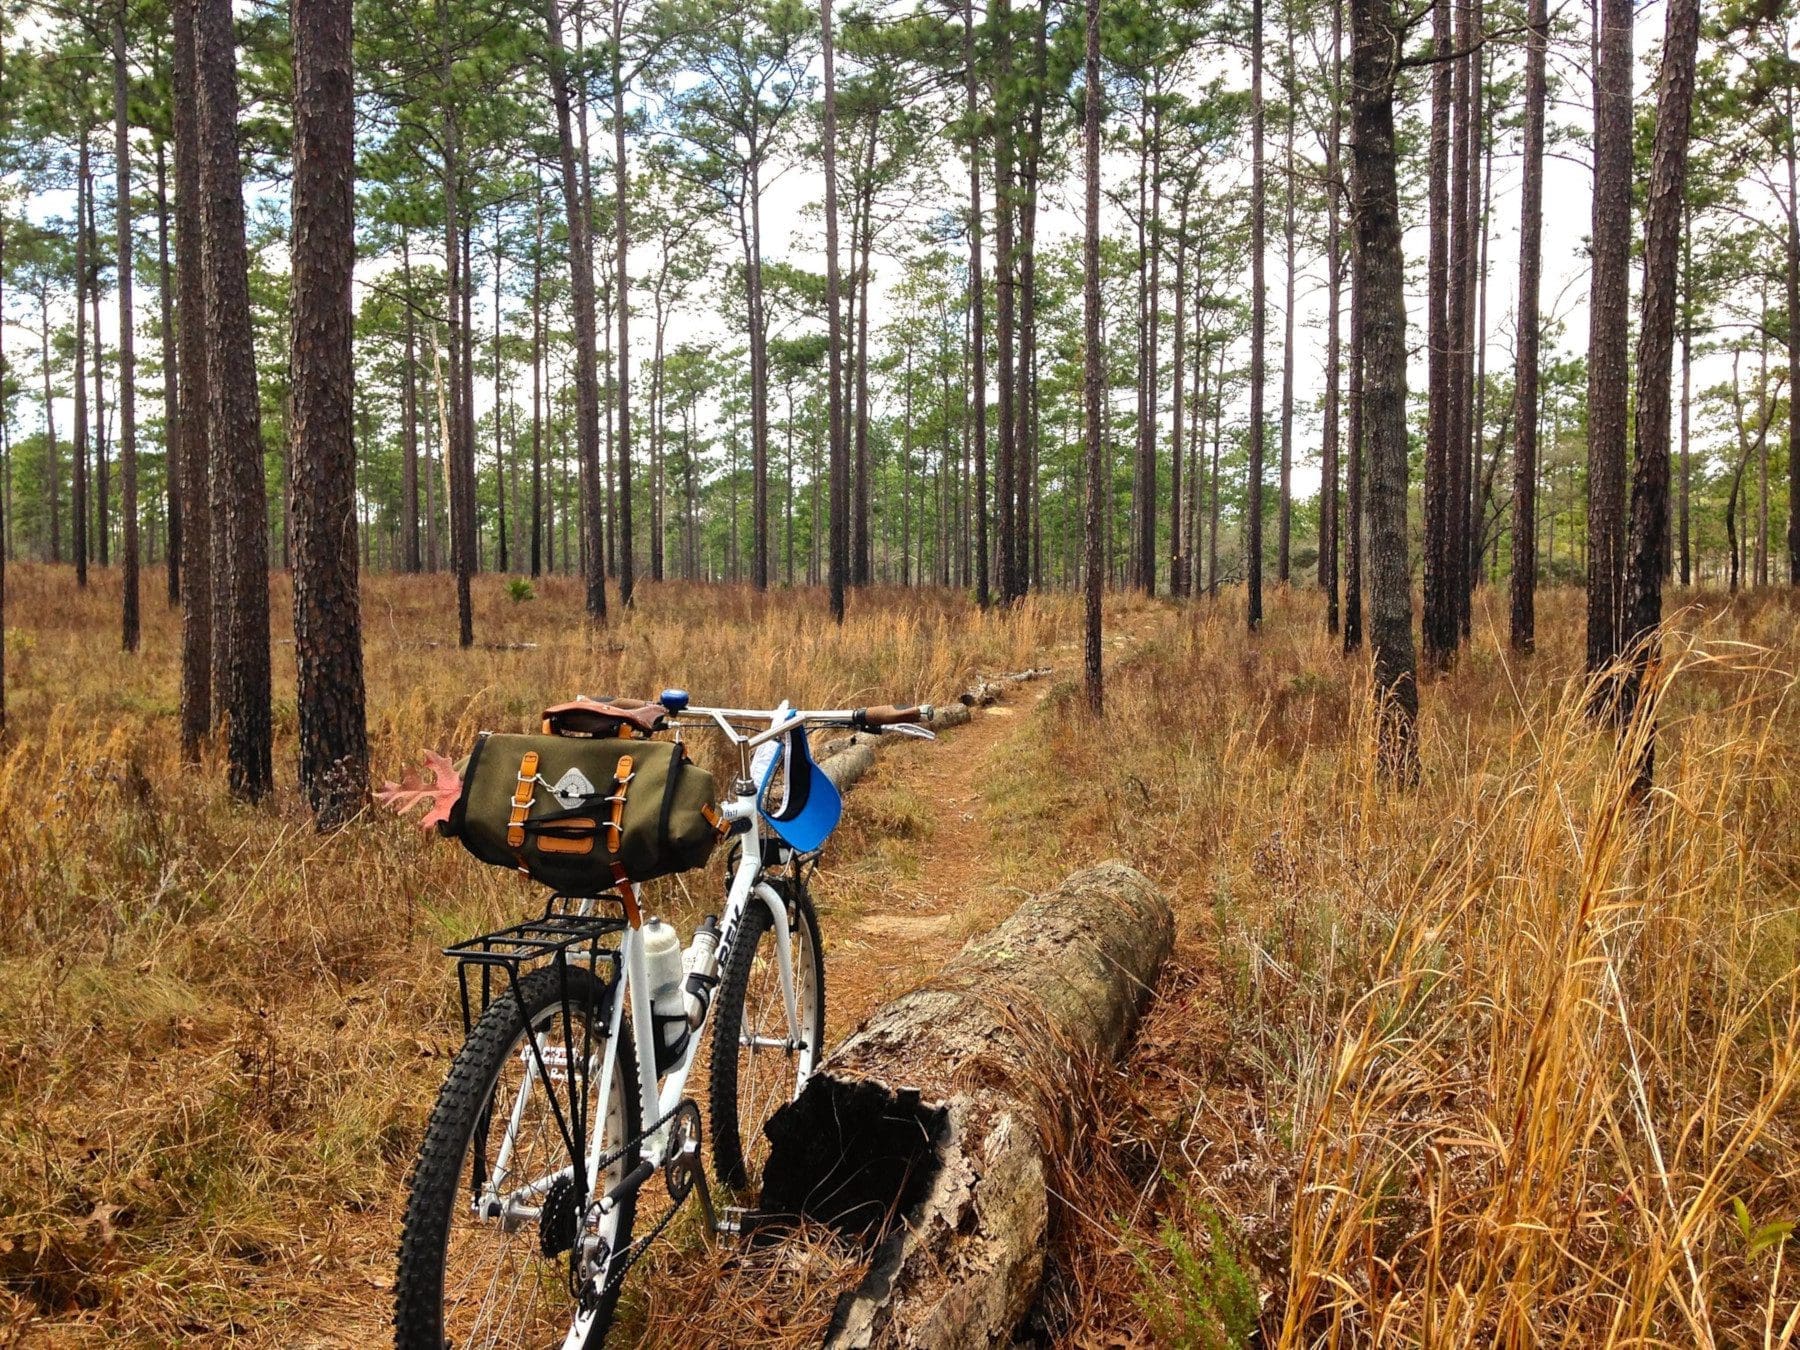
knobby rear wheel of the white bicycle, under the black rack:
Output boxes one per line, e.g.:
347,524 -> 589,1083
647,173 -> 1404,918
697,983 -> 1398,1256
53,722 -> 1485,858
394,967 -> 641,1350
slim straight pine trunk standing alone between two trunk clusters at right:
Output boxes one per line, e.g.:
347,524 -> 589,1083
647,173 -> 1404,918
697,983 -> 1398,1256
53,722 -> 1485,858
1510,0 -> 1550,652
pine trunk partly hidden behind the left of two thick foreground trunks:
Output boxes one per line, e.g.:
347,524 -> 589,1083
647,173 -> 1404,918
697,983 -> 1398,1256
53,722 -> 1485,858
171,0 -> 218,763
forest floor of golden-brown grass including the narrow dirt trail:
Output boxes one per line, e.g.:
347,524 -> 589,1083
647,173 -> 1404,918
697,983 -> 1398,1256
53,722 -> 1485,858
0,567 -> 1800,1346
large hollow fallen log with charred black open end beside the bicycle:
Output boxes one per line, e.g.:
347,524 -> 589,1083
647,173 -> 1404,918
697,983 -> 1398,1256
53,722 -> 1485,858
761,862 -> 1175,1350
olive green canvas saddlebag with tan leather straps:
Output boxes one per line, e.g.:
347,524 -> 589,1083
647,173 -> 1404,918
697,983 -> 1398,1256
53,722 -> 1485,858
445,731 -> 720,896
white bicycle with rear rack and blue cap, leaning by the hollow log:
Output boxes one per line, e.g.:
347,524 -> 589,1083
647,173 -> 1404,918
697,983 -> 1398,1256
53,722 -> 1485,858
394,689 -> 932,1350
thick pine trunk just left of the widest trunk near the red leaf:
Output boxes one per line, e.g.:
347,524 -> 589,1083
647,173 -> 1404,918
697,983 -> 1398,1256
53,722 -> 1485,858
194,0 -> 274,801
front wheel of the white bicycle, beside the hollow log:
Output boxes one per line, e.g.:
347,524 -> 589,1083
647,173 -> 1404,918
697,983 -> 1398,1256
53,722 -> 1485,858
711,880 -> 824,1192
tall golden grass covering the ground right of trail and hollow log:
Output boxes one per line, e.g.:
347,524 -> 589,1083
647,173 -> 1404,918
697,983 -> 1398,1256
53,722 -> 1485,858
1022,598 -> 1800,1346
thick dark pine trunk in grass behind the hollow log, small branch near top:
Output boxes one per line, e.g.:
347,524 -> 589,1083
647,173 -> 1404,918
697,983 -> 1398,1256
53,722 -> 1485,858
1350,0 -> 1418,783
